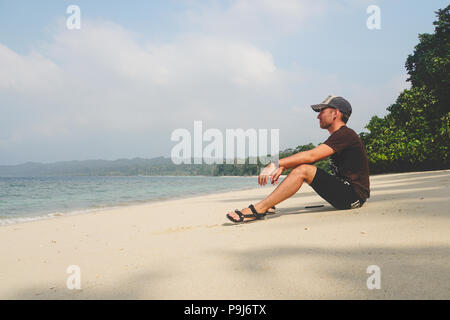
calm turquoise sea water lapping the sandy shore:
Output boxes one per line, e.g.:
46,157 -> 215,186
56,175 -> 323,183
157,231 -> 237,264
0,176 -> 264,225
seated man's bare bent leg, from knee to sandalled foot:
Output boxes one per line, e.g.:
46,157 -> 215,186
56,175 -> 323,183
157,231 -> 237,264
228,164 -> 317,221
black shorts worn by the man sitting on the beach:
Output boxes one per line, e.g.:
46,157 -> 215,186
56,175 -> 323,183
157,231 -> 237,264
310,168 -> 364,210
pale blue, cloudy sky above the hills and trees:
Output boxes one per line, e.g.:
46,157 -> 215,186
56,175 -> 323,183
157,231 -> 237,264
0,0 -> 448,165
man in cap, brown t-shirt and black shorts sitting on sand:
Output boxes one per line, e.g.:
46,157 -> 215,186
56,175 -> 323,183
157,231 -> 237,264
227,96 -> 370,223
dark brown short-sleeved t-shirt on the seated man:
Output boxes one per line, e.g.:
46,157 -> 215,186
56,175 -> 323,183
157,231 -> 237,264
324,126 -> 370,200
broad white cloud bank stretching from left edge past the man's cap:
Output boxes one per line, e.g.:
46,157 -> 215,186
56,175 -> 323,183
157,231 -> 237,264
0,0 -> 410,163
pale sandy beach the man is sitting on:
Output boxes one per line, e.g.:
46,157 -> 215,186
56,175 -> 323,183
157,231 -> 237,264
0,170 -> 450,300
